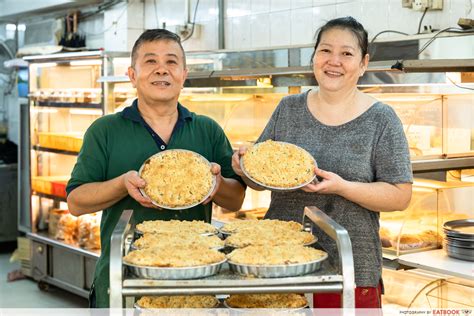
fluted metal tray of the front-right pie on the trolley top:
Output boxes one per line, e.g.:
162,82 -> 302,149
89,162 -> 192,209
227,254 -> 328,278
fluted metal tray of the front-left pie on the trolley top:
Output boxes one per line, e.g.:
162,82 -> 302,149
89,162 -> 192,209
123,259 -> 227,280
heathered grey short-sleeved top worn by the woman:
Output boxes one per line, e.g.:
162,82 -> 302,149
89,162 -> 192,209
257,92 -> 412,287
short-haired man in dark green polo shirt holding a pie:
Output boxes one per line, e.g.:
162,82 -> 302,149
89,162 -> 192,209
66,29 -> 245,307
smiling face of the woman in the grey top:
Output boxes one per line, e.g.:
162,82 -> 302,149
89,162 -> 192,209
313,28 -> 369,92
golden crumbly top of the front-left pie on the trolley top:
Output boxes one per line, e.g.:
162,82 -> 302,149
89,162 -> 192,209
123,245 -> 225,267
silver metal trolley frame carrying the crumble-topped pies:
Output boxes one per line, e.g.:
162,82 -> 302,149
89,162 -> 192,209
109,206 -> 355,308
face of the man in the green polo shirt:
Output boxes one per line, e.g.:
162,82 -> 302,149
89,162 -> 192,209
128,40 -> 188,104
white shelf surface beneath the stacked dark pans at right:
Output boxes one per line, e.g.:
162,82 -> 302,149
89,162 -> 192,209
398,249 -> 474,280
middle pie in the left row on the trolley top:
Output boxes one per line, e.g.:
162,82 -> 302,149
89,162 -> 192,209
133,233 -> 224,249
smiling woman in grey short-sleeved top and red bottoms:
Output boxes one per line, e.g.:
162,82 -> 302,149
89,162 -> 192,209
232,17 -> 412,308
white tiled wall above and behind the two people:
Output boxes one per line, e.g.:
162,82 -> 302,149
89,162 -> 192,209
140,0 -> 474,51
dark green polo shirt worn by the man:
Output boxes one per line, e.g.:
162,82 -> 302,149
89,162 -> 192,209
66,100 -> 243,307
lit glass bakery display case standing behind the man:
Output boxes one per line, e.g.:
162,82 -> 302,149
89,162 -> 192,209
19,51 -> 124,297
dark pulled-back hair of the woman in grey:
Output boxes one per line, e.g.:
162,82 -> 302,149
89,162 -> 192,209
311,16 -> 369,63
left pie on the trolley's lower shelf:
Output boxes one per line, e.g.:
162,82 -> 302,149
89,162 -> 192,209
137,295 -> 219,308
